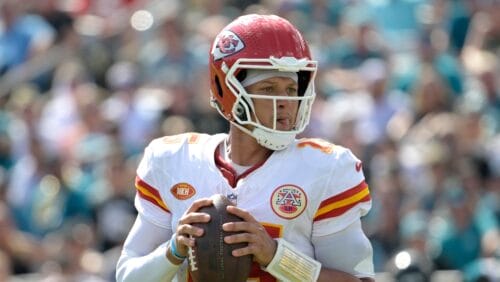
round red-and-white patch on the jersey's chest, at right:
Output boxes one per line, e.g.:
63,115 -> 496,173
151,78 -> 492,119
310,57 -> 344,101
271,184 -> 307,219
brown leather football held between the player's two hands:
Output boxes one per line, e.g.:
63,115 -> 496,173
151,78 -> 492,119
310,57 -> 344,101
188,195 -> 253,282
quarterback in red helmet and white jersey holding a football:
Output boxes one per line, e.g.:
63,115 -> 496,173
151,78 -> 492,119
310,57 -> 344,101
117,15 -> 374,282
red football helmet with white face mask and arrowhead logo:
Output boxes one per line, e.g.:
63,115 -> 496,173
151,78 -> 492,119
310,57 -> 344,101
209,14 -> 317,150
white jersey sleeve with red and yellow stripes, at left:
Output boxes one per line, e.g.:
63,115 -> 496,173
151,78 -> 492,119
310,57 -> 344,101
134,141 -> 171,228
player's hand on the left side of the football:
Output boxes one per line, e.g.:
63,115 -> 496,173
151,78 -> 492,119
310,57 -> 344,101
175,198 -> 213,257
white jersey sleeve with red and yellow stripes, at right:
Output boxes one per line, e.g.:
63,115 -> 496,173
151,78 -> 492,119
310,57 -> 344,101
313,148 -> 371,236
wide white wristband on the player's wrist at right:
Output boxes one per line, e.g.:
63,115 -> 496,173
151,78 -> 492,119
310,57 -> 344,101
262,239 -> 321,282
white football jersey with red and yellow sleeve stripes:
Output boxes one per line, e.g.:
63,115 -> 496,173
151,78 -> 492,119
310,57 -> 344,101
135,133 -> 371,281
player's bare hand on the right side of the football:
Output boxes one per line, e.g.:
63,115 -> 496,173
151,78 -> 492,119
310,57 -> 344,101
222,206 -> 277,266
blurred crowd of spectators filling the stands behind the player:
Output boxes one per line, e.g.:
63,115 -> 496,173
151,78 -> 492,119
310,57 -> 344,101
0,0 -> 500,281
